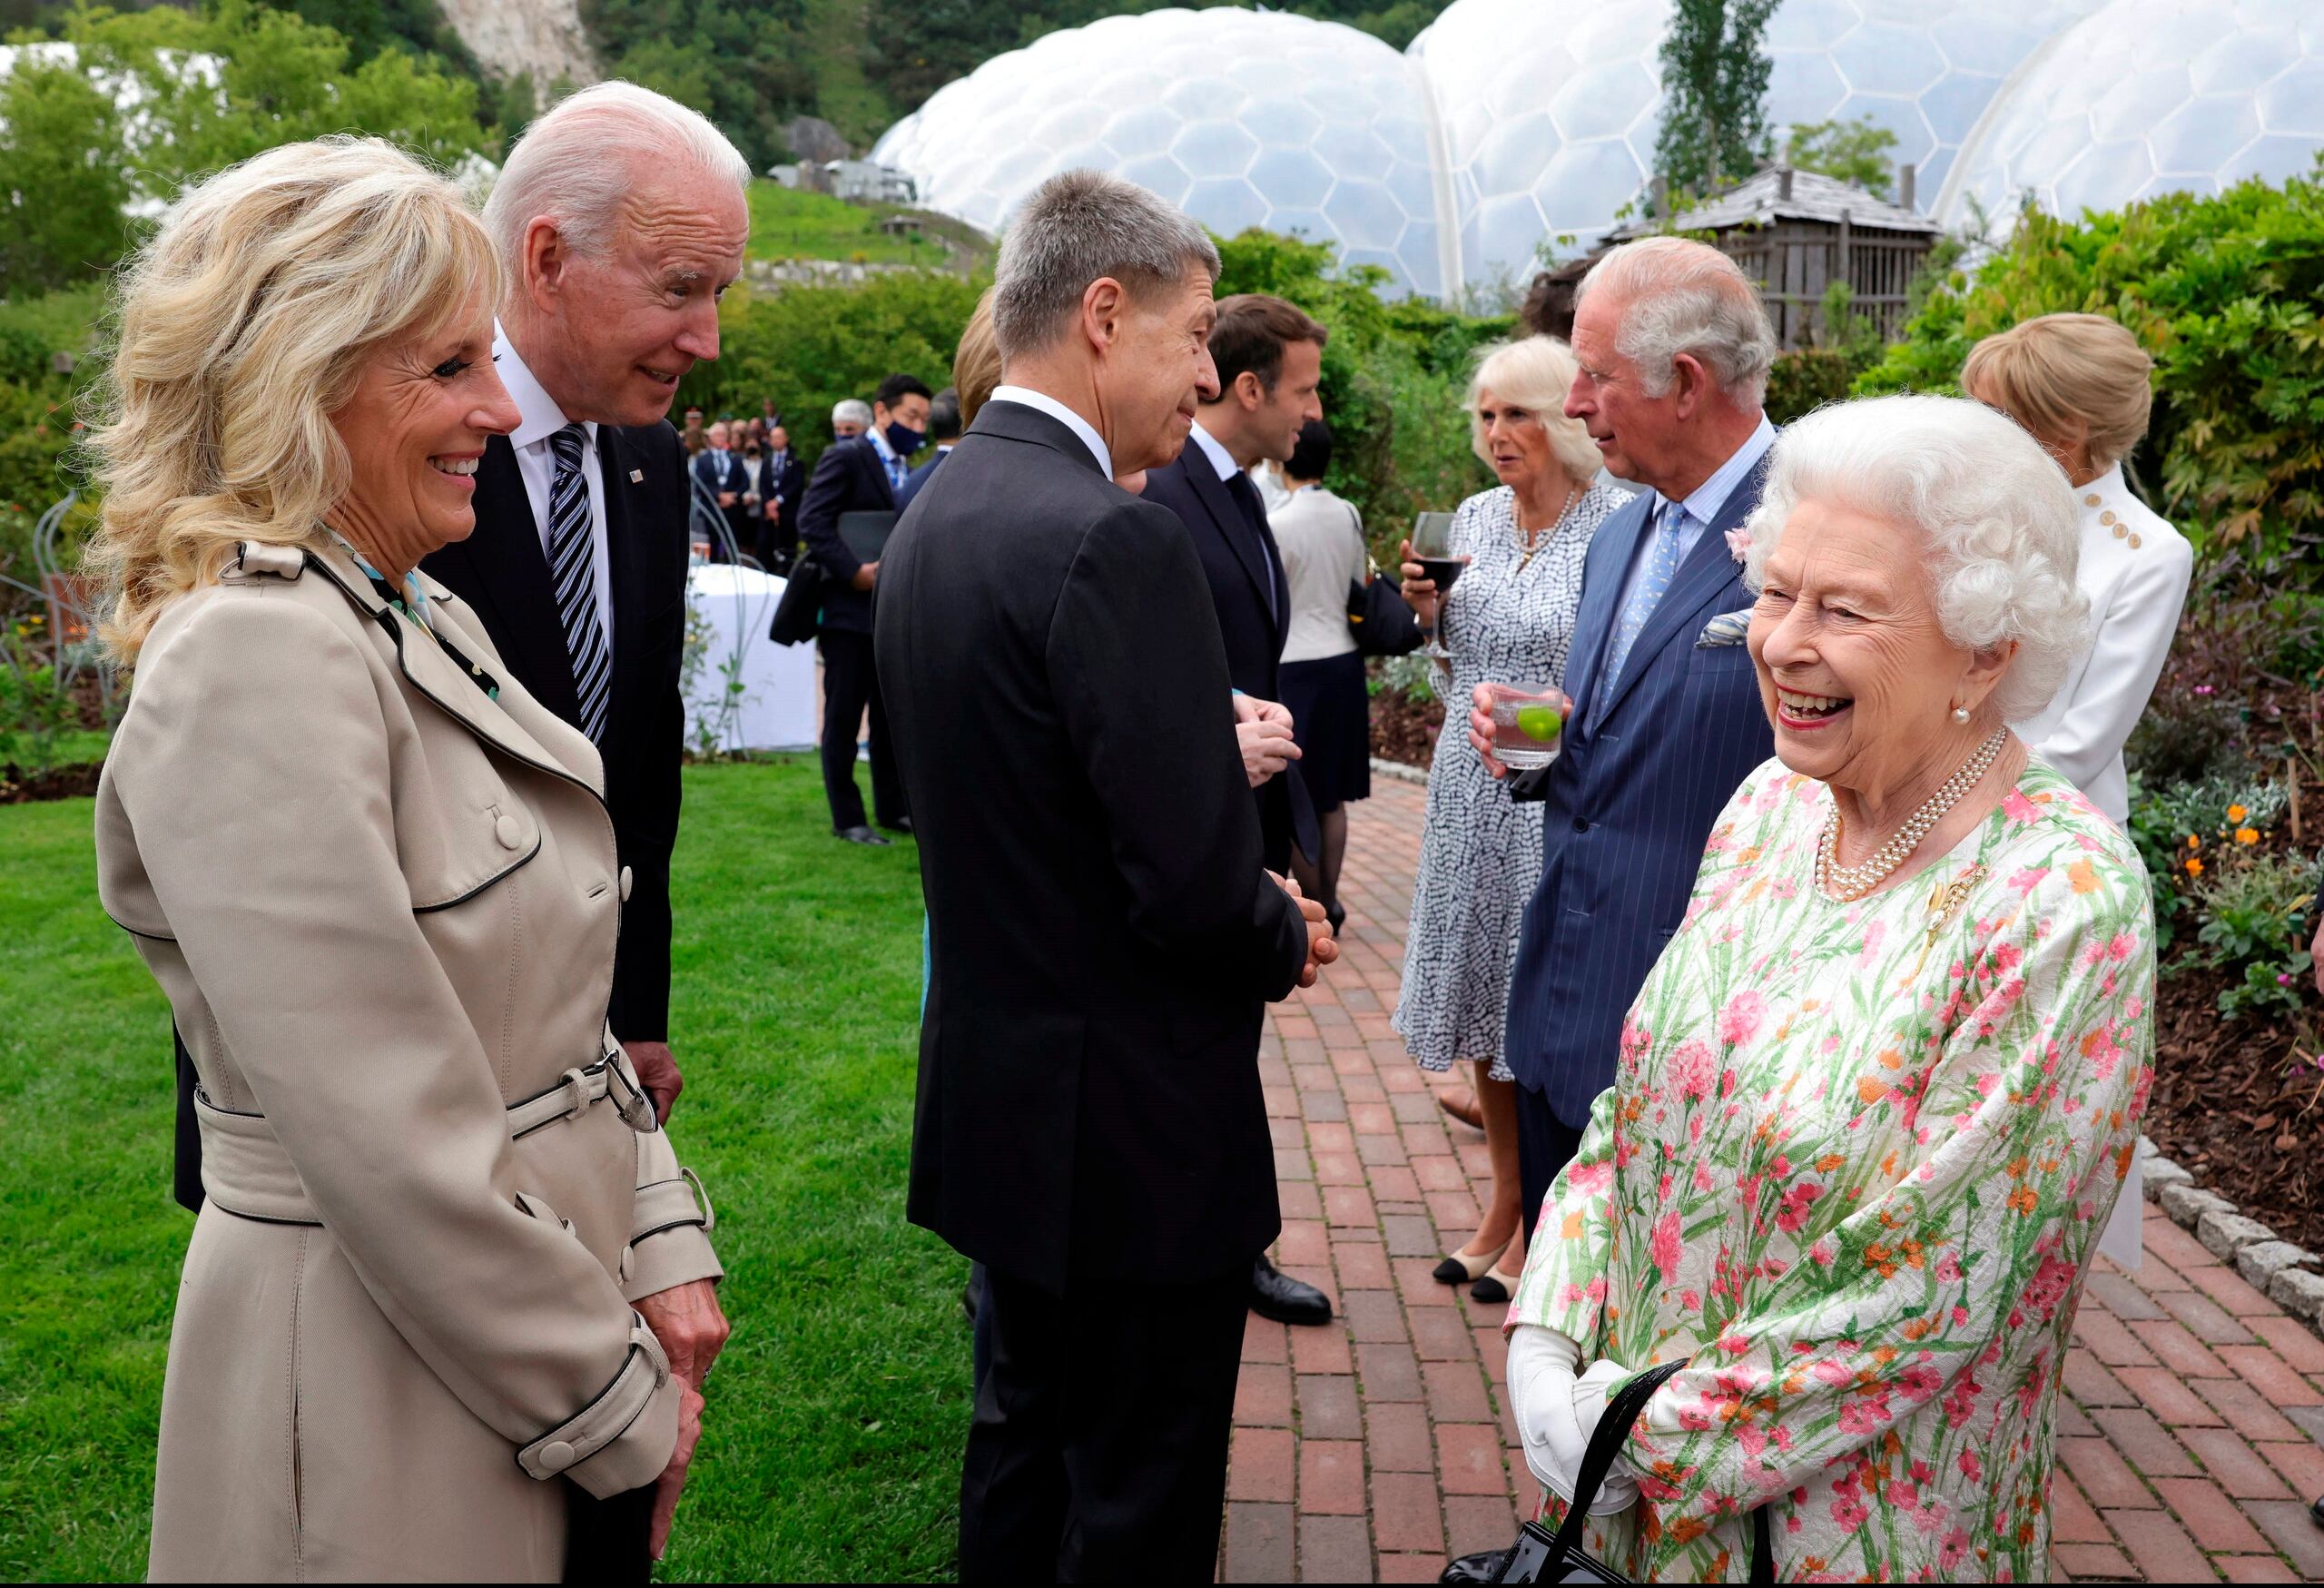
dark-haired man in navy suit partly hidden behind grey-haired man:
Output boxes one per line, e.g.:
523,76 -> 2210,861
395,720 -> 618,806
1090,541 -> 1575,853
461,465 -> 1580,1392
1144,293 -> 1332,1323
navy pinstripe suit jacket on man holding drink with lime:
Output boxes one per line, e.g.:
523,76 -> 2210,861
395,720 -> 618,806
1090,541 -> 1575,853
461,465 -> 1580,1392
1506,460 -> 1776,1125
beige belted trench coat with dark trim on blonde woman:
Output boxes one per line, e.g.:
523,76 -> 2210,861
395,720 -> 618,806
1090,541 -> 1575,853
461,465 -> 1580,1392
98,547 -> 718,1581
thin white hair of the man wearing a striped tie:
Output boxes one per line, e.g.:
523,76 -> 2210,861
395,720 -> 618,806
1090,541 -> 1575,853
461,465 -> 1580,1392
483,82 -> 751,286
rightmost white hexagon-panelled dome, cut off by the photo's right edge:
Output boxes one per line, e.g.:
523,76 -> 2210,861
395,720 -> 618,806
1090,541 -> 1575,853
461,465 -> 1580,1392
1935,0 -> 2324,223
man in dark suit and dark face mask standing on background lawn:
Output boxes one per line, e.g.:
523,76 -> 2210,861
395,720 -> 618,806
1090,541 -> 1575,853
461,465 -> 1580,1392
800,374 -> 927,844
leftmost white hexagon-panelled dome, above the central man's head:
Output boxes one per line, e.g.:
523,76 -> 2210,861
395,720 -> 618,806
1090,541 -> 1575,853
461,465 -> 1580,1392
872,7 -> 1445,295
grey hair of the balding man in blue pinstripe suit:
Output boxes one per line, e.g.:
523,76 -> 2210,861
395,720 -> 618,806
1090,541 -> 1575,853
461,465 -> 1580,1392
1573,237 -> 1776,409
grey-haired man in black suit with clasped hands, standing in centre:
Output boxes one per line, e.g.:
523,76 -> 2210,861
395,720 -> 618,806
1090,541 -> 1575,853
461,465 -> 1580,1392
876,170 -> 1336,1583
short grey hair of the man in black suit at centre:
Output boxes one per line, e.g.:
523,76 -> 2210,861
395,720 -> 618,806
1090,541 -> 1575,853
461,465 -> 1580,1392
992,170 -> 1217,362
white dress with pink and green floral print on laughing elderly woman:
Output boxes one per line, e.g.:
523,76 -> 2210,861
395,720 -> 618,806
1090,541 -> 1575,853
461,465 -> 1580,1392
1508,760 -> 2154,1581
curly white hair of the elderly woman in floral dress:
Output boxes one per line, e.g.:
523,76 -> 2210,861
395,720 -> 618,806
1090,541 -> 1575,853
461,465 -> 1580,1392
1743,398 -> 2089,723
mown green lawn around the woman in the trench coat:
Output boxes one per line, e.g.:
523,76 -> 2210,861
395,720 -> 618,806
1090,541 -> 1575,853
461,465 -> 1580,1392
0,758 -> 970,1581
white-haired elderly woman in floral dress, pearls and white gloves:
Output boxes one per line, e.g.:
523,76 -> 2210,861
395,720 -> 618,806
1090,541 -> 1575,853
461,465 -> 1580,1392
1508,398 -> 2154,1581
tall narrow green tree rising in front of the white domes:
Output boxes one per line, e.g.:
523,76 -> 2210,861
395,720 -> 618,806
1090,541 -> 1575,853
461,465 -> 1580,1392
1655,0 -> 1777,193
